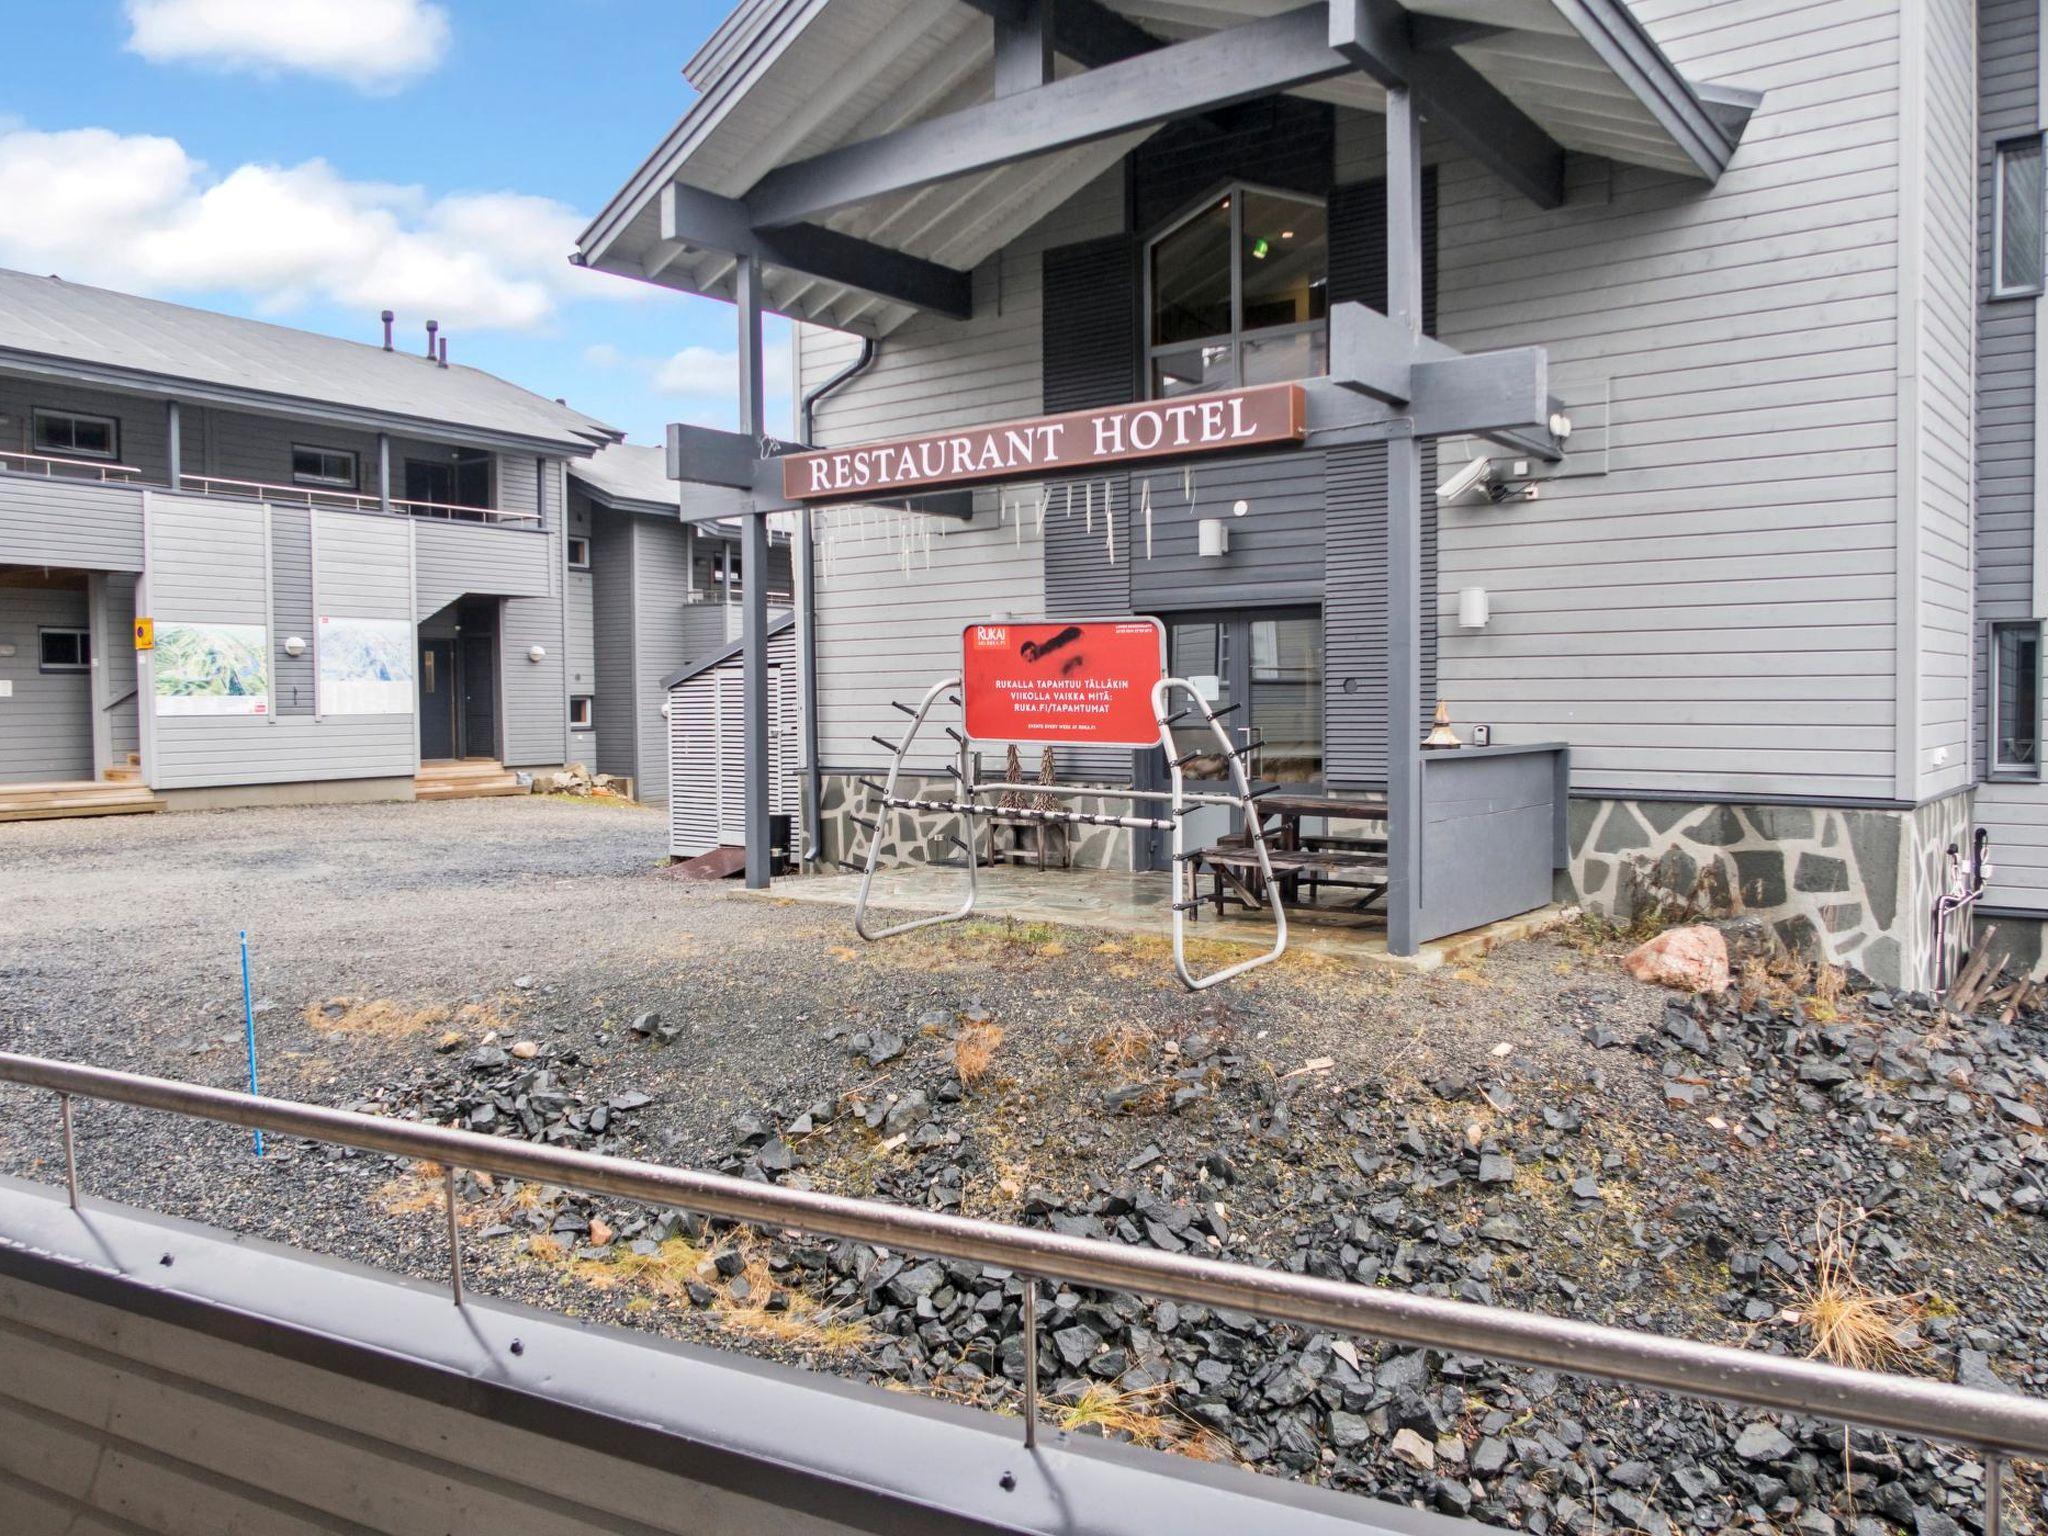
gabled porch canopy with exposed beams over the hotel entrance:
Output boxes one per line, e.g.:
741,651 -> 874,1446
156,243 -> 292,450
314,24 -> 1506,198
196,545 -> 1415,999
573,0 -> 1753,336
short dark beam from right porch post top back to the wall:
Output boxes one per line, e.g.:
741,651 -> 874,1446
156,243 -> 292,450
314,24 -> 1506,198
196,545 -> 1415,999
1329,0 -> 1565,209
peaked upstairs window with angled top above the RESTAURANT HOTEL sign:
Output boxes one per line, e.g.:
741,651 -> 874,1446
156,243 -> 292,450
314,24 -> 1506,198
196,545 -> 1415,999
1145,186 -> 1329,397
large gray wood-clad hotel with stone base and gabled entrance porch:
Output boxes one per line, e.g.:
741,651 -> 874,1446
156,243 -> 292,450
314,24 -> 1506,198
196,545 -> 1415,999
580,0 -> 2048,983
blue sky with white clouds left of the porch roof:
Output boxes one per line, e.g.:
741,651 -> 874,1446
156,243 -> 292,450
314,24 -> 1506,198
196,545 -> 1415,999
0,0 -> 788,442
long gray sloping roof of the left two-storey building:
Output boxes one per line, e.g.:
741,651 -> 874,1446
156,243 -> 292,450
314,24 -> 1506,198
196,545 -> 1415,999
0,268 -> 621,455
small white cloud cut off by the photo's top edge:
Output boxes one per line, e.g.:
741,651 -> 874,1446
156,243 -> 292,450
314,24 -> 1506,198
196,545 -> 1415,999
127,0 -> 449,90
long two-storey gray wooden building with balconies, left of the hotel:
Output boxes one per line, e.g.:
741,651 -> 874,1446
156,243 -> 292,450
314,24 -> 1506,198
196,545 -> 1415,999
0,272 -> 770,819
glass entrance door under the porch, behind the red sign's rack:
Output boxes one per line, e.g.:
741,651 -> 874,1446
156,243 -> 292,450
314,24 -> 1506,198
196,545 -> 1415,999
1141,608 -> 1323,868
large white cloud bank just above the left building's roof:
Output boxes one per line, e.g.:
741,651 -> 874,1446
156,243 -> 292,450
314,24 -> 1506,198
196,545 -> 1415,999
0,129 -> 637,330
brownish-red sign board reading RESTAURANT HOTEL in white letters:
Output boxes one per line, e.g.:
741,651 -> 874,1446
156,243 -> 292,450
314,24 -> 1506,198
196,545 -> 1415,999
782,383 -> 1307,502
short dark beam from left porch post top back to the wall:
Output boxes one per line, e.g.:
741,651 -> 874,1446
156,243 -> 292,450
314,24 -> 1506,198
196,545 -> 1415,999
649,182 -> 975,319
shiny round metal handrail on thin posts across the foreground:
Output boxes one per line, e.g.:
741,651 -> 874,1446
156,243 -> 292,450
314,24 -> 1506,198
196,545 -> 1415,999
0,1053 -> 2048,1536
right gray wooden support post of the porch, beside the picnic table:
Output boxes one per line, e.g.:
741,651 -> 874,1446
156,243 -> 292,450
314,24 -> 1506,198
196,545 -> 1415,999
1386,88 -> 1434,954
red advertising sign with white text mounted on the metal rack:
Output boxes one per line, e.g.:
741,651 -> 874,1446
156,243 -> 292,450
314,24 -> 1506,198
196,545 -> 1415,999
961,618 -> 1165,748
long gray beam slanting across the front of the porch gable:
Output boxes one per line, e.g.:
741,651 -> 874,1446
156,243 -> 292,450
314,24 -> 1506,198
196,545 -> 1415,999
745,4 -> 1351,227
